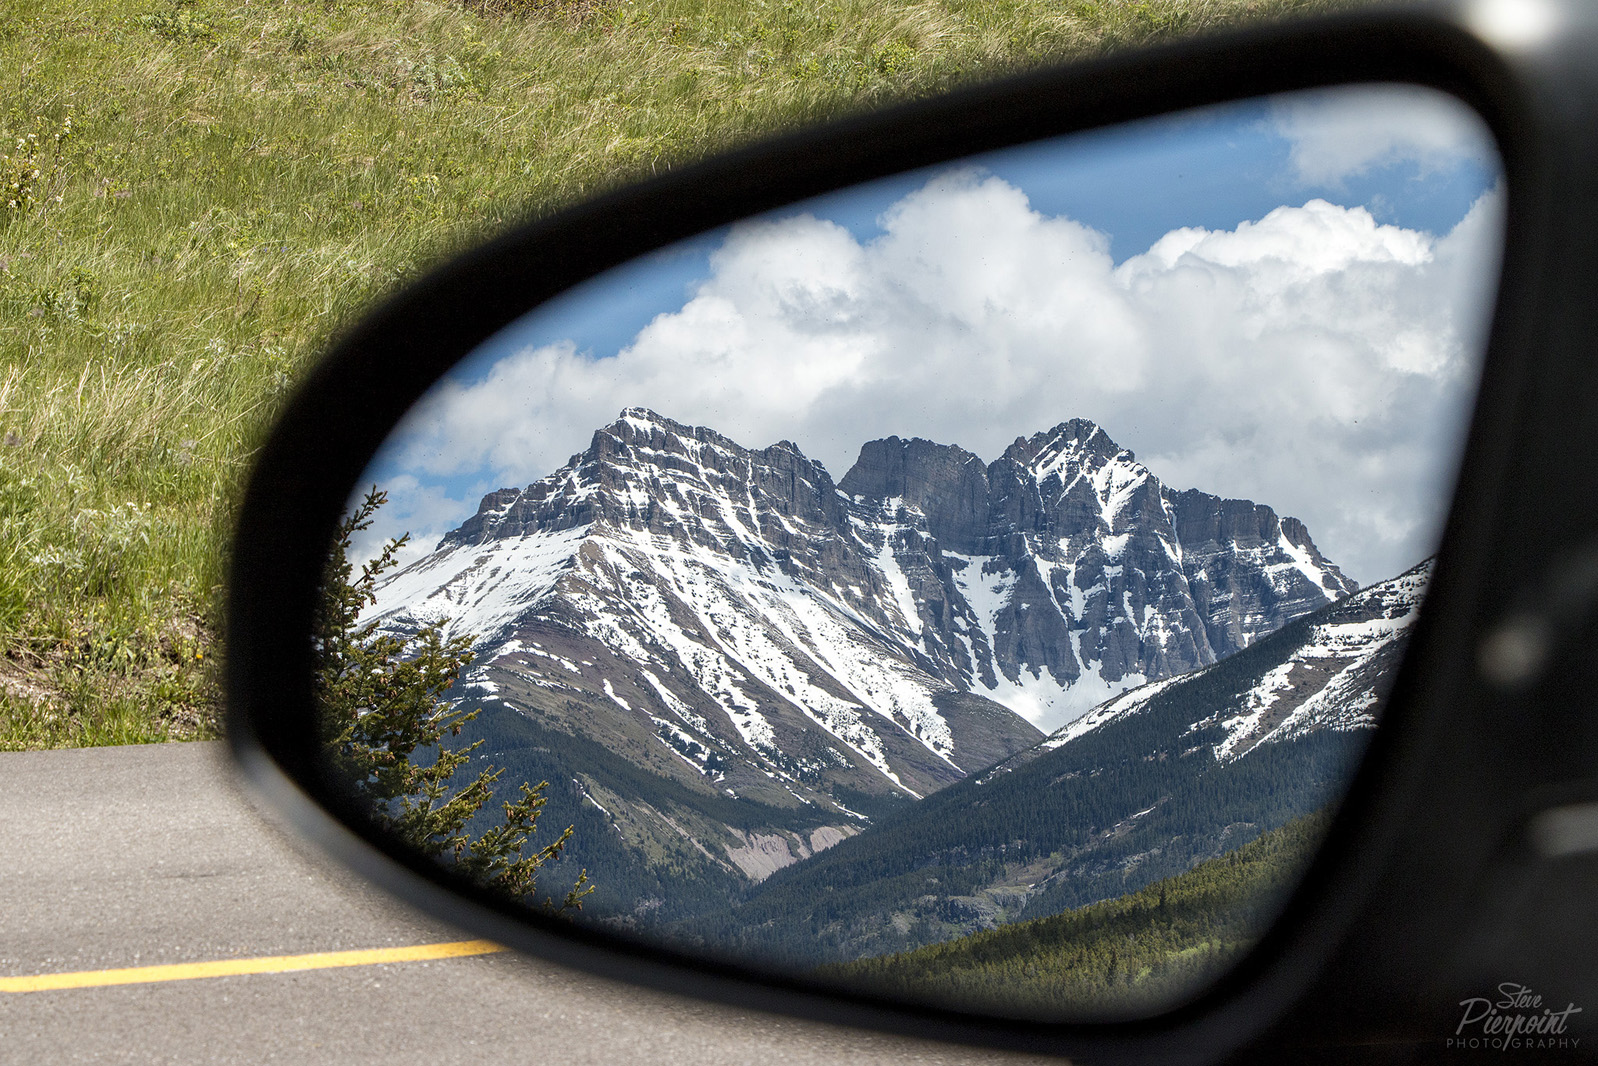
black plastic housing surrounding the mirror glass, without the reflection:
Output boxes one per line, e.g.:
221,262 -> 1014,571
227,0 -> 1598,1063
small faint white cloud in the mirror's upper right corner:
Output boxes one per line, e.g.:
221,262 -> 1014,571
1270,85 -> 1493,187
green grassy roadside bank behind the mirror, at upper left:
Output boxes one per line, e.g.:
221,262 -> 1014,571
0,0 -> 1355,748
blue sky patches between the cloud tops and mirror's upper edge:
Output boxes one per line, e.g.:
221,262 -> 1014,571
462,92 -> 1497,374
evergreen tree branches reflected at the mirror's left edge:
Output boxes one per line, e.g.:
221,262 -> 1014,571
313,487 -> 593,913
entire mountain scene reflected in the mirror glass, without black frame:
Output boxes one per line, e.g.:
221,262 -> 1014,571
318,86 -> 1504,1020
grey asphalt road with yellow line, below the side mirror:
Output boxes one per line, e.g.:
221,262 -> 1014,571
0,743 -> 1059,1066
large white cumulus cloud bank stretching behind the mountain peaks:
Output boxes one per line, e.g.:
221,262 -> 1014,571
380,169 -> 1501,580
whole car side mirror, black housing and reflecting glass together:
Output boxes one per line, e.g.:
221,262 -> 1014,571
227,3 -> 1598,1060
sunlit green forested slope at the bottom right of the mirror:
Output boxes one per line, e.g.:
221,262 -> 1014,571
815,813 -> 1328,1021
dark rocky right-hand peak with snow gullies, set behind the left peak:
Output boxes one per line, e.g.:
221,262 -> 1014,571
839,419 -> 1357,727
